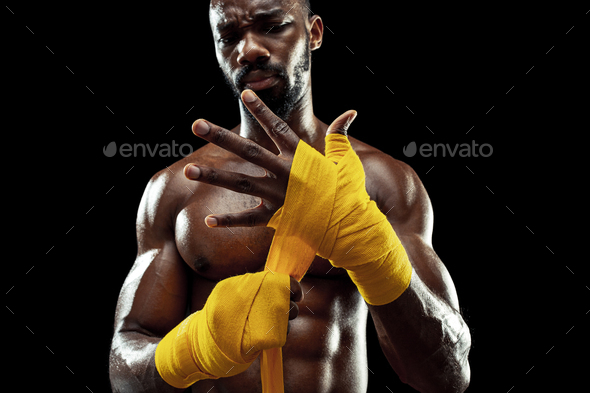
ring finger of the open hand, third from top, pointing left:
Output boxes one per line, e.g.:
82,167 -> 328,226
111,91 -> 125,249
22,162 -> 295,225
184,164 -> 282,203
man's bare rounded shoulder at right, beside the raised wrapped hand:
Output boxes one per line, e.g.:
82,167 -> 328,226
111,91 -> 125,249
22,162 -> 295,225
349,137 -> 433,242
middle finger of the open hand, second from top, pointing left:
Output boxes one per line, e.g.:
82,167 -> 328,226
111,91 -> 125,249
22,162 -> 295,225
192,119 -> 289,174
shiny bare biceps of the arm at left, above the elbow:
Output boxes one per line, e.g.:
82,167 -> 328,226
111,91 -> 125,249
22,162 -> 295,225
115,245 -> 188,337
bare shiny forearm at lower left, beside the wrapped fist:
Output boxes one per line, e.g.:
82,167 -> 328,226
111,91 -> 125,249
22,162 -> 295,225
109,331 -> 184,393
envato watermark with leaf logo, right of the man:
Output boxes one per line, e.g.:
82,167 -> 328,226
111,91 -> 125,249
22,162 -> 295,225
403,141 -> 494,157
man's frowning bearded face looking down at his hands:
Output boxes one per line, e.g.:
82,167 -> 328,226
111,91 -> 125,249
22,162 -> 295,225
209,0 -> 311,120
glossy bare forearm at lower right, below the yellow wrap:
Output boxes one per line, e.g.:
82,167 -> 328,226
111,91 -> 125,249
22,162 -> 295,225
369,274 -> 471,392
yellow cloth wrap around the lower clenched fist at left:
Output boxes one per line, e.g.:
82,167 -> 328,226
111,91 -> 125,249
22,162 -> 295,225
155,270 -> 290,388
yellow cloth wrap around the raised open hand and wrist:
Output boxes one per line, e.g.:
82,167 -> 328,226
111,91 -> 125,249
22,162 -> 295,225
267,134 -> 412,305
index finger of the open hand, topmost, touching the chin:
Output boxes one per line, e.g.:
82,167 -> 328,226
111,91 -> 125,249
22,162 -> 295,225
242,90 -> 299,156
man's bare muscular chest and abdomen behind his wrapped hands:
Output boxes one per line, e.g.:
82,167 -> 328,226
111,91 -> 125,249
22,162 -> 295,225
171,127 -> 388,393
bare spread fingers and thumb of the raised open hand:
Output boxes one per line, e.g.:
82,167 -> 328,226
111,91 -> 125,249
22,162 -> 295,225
184,90 -> 356,227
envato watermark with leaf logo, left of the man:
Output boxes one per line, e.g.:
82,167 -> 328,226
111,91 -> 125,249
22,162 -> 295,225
102,141 -> 193,158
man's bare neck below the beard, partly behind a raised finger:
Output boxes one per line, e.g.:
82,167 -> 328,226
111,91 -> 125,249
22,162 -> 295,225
238,88 -> 327,154
